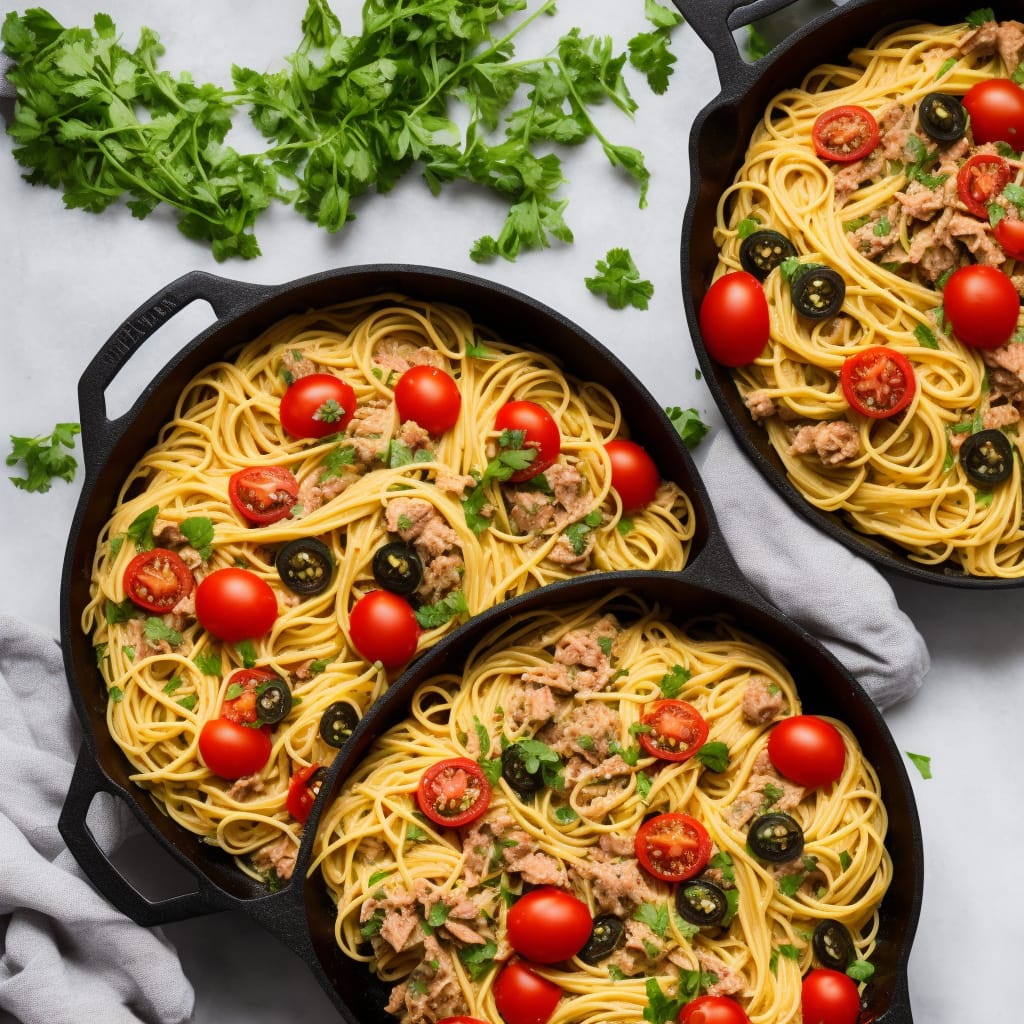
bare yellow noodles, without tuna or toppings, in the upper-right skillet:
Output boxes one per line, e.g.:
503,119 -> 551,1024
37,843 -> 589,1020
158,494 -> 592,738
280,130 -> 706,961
716,18 -> 1024,578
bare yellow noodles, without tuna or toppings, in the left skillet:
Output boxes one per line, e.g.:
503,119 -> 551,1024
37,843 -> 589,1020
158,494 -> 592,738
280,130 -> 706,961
82,295 -> 695,874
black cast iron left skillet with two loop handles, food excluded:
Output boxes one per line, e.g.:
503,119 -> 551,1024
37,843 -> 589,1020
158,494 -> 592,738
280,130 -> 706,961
54,265 -> 722,926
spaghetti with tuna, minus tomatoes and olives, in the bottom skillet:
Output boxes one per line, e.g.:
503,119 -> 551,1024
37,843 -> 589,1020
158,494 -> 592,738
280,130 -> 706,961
313,591 -> 892,1024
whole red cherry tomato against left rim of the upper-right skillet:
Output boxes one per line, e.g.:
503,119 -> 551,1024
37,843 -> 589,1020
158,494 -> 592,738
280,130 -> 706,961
699,270 -> 771,367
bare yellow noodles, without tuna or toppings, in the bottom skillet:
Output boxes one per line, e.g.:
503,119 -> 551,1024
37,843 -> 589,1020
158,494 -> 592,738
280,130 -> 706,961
313,592 -> 892,1024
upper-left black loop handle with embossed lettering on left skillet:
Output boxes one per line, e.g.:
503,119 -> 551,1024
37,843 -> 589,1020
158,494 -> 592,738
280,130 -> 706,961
78,270 -> 266,479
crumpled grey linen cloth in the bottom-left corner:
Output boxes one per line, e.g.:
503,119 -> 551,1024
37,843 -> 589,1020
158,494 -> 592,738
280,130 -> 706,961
0,615 -> 194,1024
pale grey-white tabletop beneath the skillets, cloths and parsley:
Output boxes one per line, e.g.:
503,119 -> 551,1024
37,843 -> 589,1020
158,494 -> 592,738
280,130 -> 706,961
0,0 -> 1024,1024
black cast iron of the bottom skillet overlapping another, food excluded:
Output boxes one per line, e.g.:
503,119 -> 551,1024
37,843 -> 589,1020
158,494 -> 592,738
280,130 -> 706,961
305,577 -> 923,1024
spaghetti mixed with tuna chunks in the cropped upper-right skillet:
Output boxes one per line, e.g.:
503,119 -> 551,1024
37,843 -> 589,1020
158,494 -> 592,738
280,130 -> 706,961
716,19 -> 1024,578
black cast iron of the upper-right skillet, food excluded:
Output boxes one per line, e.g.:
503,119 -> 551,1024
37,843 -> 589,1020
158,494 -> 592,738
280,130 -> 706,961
674,0 -> 1024,589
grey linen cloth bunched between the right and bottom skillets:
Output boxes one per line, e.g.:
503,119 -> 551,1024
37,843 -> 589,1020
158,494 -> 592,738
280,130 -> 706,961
697,429 -> 931,708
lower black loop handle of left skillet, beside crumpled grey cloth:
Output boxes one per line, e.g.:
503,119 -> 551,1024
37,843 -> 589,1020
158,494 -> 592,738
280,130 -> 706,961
57,745 -> 237,928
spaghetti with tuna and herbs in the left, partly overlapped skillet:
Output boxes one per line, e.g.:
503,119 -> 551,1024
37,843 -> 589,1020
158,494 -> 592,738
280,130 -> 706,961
82,295 -> 694,881
